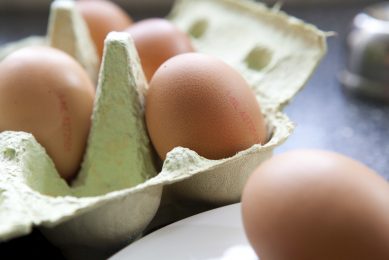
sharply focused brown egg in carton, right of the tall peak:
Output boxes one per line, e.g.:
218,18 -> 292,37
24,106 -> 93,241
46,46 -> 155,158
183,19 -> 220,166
145,53 -> 266,159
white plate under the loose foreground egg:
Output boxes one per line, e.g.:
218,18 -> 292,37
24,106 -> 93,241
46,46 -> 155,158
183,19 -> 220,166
110,204 -> 258,260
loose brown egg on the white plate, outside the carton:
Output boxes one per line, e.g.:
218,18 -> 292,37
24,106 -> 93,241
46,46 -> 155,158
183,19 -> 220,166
242,150 -> 389,260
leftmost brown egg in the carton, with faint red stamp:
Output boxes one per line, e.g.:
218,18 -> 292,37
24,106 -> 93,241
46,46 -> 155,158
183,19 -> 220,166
0,47 -> 94,180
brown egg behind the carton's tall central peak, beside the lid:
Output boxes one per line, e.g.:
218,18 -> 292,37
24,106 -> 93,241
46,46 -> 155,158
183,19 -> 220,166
126,18 -> 194,80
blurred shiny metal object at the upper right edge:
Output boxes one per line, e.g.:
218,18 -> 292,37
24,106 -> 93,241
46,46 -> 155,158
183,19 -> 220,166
340,2 -> 389,101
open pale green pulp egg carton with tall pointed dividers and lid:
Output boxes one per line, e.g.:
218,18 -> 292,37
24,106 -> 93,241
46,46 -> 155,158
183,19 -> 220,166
0,0 -> 326,258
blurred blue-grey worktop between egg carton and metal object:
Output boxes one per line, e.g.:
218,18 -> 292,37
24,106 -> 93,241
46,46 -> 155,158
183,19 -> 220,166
277,6 -> 389,179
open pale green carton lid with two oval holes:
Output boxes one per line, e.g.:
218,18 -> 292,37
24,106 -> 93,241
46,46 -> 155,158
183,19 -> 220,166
169,0 -> 326,110
